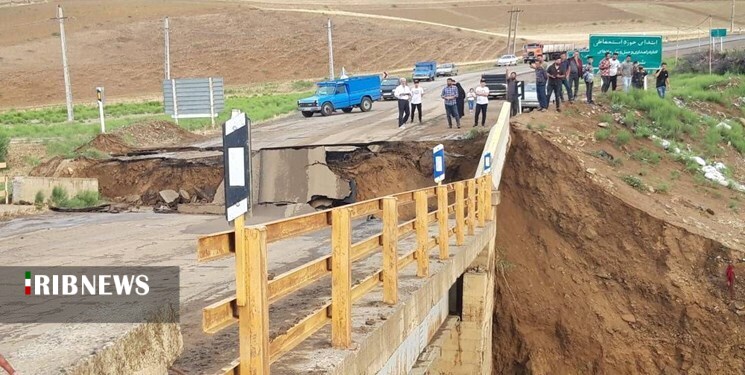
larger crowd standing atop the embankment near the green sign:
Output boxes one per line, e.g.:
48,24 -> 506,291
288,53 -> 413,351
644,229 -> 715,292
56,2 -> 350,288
528,50 -> 670,112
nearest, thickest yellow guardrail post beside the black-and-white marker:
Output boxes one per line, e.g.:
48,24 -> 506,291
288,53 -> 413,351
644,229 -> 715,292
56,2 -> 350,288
243,226 -> 269,375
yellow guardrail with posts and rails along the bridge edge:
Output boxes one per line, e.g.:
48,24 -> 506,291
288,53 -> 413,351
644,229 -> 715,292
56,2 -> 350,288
197,174 -> 492,375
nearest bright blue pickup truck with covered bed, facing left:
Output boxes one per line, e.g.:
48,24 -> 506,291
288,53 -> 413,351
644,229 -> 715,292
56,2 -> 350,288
297,76 -> 380,117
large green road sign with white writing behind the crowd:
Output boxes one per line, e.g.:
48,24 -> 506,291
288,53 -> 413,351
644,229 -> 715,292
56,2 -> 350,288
580,34 -> 662,69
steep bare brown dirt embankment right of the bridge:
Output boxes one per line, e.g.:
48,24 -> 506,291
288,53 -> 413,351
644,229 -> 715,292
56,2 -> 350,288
493,130 -> 745,374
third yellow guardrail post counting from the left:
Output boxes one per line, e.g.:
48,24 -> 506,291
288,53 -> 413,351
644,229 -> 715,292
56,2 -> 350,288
381,197 -> 398,305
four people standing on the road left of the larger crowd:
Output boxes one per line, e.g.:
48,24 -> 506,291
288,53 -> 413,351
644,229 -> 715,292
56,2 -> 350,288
393,78 -> 489,129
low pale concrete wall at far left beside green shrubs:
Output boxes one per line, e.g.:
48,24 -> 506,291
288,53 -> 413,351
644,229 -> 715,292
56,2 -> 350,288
13,177 -> 98,204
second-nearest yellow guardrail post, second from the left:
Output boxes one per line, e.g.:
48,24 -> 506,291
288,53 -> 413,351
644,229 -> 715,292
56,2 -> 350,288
331,208 -> 352,349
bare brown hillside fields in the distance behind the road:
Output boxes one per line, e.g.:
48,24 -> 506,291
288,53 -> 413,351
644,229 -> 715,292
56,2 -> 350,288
0,0 -> 745,109
